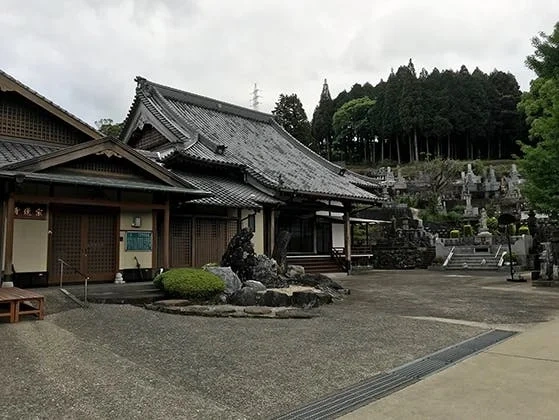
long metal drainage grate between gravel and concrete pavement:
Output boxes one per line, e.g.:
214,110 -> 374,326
275,330 -> 516,420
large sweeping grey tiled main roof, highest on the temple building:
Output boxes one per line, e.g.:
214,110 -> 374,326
126,79 -> 379,202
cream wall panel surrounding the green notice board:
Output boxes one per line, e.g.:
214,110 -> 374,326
119,210 -> 154,270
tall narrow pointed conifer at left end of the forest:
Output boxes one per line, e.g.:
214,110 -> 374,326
311,79 -> 334,159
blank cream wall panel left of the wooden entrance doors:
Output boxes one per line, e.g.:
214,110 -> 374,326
13,219 -> 49,273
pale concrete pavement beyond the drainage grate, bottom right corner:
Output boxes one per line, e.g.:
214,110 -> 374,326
343,319 -> 559,420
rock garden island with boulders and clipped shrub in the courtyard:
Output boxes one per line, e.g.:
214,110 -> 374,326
146,228 -> 349,318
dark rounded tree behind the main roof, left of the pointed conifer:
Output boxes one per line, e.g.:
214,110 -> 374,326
272,93 -> 313,147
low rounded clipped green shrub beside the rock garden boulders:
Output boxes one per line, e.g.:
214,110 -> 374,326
154,268 -> 225,299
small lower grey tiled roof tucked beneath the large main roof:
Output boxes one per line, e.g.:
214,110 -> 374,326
173,171 -> 281,208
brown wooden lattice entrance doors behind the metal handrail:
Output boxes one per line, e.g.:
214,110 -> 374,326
49,207 -> 118,284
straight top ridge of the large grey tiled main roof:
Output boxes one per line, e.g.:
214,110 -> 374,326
134,76 -> 274,121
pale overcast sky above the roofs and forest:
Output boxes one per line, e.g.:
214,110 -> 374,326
0,0 -> 559,123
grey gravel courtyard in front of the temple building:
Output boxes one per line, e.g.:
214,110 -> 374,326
0,270 -> 559,419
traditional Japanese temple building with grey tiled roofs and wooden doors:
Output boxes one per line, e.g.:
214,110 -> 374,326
0,72 -> 379,287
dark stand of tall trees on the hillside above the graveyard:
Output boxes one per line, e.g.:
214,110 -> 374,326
272,59 -> 527,165
